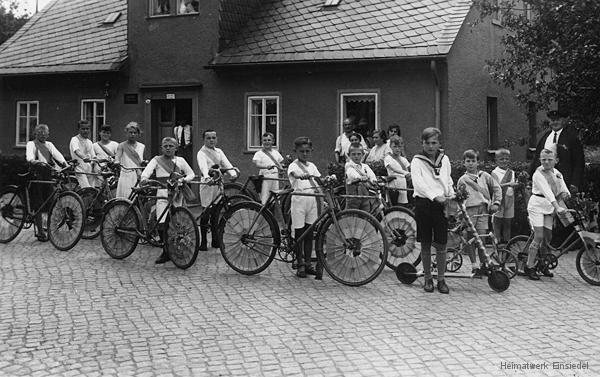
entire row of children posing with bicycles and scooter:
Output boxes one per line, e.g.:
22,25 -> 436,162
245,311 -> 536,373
26,120 -> 569,284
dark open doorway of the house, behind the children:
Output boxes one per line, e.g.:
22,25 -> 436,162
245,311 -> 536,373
150,99 -> 194,166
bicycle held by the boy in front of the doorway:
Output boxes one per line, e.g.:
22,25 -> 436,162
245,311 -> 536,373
100,179 -> 200,269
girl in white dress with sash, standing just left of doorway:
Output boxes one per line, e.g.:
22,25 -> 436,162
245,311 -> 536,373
115,122 -> 146,198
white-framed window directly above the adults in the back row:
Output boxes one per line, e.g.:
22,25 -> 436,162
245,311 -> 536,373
339,91 -> 379,138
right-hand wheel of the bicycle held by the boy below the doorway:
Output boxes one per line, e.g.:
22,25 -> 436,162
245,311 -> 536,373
166,207 -> 200,269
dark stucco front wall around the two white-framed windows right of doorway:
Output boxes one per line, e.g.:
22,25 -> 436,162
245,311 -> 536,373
205,61 -> 435,171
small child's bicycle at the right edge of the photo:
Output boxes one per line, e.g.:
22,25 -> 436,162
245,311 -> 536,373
506,197 -> 600,286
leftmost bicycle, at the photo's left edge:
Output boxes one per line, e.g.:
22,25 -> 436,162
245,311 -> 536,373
0,162 -> 85,251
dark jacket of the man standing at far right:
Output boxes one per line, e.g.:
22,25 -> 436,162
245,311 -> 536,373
529,127 -> 585,190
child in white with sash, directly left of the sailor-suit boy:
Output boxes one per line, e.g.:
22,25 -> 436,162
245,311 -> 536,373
383,136 -> 410,205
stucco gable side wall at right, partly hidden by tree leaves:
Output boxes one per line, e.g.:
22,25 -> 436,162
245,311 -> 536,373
445,10 -> 528,159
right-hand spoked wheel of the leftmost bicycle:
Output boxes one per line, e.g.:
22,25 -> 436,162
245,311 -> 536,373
48,191 -> 85,251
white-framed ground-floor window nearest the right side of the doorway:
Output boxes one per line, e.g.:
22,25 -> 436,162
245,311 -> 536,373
247,96 -> 280,150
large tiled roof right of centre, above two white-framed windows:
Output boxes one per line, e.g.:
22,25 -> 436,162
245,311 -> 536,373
210,0 -> 472,67
